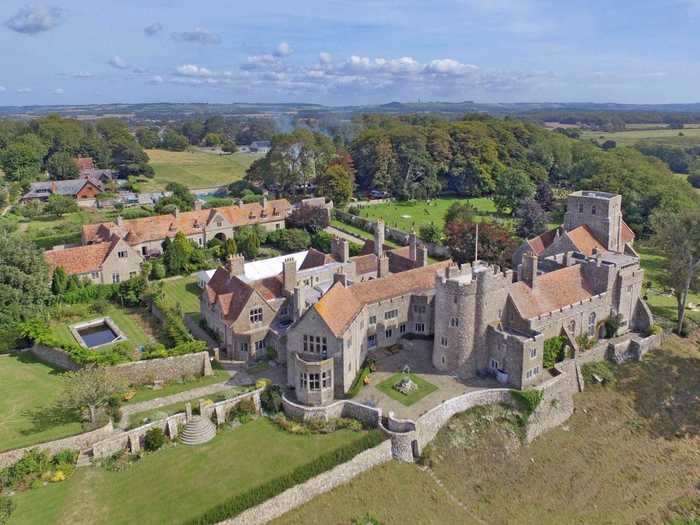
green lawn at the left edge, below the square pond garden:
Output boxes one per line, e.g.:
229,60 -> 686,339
0,356 -> 82,450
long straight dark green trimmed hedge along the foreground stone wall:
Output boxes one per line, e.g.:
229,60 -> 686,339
185,429 -> 385,525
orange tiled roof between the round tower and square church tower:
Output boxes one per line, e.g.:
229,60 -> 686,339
510,264 -> 594,319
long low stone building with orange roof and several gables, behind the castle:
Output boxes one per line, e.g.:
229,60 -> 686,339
81,199 -> 290,256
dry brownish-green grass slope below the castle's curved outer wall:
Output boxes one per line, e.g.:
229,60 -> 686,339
273,337 -> 700,525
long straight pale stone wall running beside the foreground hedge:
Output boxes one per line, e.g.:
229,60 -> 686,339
220,441 -> 391,525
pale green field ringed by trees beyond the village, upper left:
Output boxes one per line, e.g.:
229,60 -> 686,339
141,149 -> 261,191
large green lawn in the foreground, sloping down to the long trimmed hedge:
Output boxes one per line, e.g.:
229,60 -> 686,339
10,418 -> 372,525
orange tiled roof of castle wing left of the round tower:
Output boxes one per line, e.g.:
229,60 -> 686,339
314,260 -> 452,336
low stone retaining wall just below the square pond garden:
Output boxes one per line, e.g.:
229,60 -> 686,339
109,352 -> 214,385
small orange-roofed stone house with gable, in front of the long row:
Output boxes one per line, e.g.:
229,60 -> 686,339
44,235 -> 143,284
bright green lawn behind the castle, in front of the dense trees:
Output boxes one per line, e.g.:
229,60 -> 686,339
360,198 -> 497,232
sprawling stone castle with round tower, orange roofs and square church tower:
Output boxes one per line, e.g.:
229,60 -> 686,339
202,191 -> 653,405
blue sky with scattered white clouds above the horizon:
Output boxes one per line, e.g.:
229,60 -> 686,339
0,0 -> 700,106
